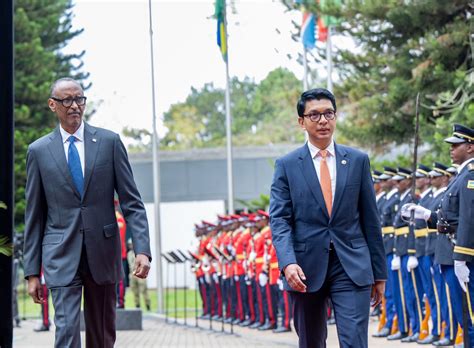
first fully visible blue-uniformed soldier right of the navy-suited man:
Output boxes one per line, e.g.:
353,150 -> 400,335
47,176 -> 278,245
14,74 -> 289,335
388,168 -> 423,343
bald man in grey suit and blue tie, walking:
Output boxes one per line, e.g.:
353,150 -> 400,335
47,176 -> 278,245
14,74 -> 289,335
24,78 -> 151,347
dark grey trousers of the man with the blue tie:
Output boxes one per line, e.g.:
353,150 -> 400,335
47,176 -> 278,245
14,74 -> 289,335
50,249 -> 116,348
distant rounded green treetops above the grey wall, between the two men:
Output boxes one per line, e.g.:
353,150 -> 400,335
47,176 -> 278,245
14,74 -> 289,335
156,68 -> 304,149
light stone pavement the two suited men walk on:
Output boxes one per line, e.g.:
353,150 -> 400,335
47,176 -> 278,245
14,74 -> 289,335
13,315 -> 406,348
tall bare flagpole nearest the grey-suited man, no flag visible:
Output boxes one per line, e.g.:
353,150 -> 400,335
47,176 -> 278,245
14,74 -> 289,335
148,0 -> 164,313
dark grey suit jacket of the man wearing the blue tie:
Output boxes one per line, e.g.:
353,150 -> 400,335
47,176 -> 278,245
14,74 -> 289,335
24,124 -> 151,287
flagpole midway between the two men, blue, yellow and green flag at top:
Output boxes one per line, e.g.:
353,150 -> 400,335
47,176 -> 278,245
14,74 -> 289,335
224,0 -> 234,214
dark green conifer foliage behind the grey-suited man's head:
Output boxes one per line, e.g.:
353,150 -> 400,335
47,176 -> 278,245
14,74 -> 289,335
14,0 -> 88,231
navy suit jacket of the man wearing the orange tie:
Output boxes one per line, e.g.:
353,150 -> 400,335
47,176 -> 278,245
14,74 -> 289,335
270,144 -> 387,292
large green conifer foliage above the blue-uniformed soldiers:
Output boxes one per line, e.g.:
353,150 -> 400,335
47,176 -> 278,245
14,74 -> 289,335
336,0 -> 474,159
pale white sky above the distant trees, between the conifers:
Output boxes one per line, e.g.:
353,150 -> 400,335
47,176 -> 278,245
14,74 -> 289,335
65,0 -> 303,141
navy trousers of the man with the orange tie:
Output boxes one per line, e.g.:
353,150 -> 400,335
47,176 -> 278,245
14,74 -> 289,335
290,250 -> 371,348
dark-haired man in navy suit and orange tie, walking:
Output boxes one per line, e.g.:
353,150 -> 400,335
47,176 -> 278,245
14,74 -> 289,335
270,88 -> 387,348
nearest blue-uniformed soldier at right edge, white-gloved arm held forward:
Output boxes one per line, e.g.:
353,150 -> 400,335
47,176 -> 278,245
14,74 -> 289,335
409,124 -> 474,346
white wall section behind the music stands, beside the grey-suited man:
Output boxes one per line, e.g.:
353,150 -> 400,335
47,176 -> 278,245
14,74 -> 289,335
145,201 -> 225,288
